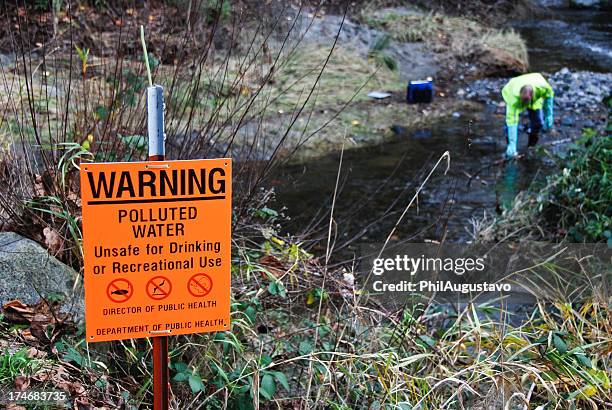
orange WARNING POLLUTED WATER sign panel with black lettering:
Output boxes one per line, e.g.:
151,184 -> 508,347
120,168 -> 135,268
81,159 -> 232,342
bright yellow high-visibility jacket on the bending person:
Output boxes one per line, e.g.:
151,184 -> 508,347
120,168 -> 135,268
502,73 -> 555,125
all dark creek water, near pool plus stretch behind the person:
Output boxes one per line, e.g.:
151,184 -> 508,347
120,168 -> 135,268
273,10 -> 612,250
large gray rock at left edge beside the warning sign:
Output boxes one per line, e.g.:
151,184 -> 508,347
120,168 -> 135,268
0,232 -> 84,320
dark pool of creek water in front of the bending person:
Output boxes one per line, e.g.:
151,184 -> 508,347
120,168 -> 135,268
275,110 -> 547,243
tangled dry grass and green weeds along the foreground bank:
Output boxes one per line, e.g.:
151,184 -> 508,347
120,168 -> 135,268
2,232 -> 612,409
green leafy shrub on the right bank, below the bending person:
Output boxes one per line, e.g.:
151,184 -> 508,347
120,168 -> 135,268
472,126 -> 612,242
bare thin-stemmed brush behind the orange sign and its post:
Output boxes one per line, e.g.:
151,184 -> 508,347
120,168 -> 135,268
0,0 -> 346,268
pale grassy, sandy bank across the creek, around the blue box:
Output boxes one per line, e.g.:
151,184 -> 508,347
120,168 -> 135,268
230,4 -> 527,163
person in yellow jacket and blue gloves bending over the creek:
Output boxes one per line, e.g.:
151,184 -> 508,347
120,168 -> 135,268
502,73 -> 555,158
